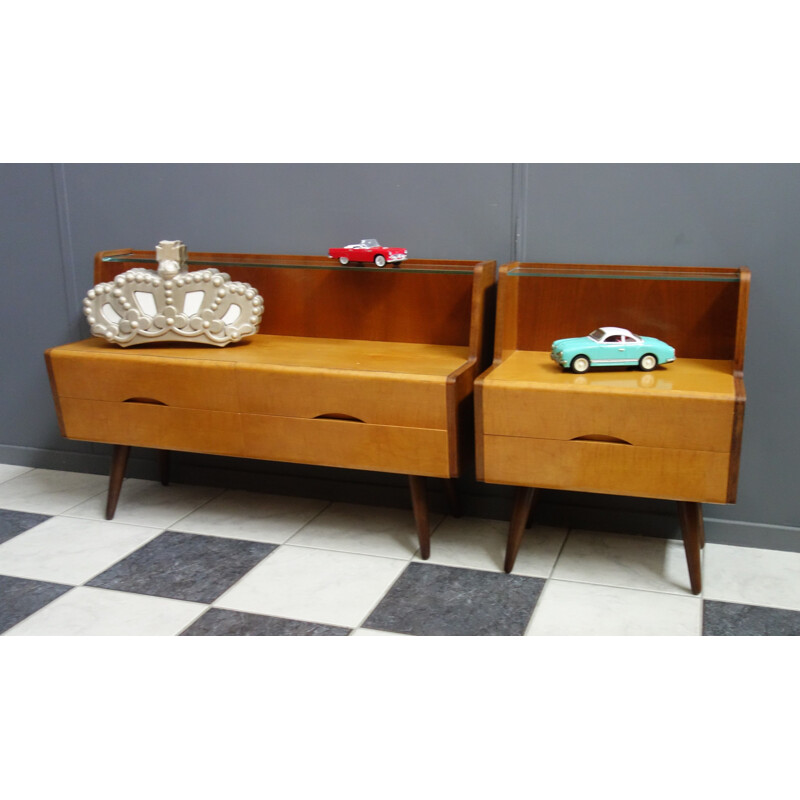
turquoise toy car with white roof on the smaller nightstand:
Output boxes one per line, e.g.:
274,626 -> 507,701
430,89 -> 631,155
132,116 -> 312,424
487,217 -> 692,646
550,327 -> 675,373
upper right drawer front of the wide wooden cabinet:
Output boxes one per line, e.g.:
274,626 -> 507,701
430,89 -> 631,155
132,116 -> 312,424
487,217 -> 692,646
236,364 -> 447,430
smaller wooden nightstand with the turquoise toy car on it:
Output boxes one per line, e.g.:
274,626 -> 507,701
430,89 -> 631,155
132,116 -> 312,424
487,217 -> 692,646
475,263 -> 750,594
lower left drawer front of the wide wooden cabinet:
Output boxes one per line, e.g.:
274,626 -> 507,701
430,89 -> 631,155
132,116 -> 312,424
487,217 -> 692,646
60,397 -> 242,456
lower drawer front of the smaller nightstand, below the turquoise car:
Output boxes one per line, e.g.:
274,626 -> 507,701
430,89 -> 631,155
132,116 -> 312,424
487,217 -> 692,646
482,436 -> 730,503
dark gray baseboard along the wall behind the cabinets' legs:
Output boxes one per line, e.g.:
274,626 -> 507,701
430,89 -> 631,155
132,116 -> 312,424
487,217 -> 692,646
0,445 -> 800,553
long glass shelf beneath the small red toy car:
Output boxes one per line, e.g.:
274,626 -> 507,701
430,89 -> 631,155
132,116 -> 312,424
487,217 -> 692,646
103,253 -> 481,275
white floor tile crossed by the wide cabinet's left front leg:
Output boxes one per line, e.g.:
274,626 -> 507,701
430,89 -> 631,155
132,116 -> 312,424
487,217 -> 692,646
66,478 -> 223,530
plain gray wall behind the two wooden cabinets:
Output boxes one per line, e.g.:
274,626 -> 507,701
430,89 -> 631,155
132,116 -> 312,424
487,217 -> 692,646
0,164 -> 800,549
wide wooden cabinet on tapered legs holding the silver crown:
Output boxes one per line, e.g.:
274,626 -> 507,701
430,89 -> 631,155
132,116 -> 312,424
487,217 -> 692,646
45,250 -> 495,558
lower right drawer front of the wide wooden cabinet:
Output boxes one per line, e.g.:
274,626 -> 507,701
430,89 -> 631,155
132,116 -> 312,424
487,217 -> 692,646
242,414 -> 457,478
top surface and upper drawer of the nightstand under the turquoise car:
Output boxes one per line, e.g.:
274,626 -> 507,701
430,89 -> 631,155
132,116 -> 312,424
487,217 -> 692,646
482,351 -> 736,453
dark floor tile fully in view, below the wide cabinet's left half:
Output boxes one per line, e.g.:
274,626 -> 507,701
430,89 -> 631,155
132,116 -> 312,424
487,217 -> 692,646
86,531 -> 276,603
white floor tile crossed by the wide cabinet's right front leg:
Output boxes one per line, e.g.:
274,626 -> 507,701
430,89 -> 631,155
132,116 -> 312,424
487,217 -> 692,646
282,503 -> 428,560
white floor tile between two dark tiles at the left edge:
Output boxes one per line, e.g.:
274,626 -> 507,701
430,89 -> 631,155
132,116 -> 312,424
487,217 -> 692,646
0,517 -> 159,584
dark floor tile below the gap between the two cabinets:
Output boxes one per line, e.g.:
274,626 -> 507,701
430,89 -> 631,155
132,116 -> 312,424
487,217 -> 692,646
364,563 -> 545,636
